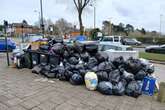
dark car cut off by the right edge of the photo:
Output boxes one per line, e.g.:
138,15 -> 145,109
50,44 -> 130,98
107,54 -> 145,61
145,45 -> 165,54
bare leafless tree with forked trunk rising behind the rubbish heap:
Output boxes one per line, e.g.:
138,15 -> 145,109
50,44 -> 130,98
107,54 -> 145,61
73,0 -> 92,35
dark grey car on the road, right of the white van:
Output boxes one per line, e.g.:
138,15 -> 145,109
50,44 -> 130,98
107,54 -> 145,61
121,38 -> 142,45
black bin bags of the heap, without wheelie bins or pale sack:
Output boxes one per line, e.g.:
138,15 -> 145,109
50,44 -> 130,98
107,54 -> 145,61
32,40 -> 154,97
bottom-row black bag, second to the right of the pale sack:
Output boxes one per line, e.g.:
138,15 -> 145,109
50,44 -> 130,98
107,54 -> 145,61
113,82 -> 125,96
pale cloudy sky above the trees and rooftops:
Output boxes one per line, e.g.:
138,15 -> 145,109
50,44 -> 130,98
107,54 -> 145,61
0,0 -> 165,32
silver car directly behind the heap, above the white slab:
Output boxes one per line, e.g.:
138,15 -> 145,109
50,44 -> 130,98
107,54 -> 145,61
99,42 -> 133,51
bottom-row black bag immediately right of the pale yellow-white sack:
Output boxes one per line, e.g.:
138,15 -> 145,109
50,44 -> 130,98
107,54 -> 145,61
97,81 -> 113,95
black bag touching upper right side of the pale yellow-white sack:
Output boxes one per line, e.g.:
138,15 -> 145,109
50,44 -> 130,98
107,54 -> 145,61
96,71 -> 109,82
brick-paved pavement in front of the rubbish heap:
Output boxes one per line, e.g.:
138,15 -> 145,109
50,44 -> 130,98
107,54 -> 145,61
0,54 -> 165,110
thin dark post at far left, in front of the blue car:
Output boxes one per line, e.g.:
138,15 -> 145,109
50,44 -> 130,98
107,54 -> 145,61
4,20 -> 10,66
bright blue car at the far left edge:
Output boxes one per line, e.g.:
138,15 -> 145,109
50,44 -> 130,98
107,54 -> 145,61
0,39 -> 16,52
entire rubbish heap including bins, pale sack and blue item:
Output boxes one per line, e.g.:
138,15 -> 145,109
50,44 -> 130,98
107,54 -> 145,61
17,38 -> 157,98
